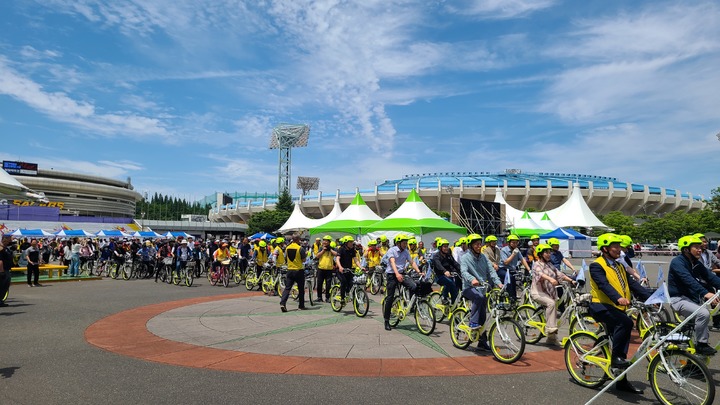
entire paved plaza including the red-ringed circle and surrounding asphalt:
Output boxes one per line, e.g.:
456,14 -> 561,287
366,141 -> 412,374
0,258 -> 720,404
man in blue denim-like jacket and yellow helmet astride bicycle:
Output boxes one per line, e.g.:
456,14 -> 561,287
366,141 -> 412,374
460,233 -> 503,350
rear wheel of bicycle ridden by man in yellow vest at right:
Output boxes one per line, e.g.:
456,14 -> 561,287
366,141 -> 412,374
565,332 -> 610,388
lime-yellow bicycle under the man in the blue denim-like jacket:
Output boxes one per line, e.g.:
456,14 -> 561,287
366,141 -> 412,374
450,285 -> 525,364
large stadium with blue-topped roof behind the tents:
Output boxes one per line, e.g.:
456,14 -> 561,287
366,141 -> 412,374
206,169 -> 705,223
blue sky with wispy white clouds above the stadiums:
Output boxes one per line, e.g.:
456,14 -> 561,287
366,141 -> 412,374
0,0 -> 720,202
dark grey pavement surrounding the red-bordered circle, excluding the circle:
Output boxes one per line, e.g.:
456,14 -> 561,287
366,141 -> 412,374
0,258 -> 720,405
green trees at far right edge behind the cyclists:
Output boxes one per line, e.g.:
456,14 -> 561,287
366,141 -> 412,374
600,187 -> 720,243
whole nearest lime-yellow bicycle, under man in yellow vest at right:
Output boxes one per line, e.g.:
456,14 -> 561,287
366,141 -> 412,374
563,302 -> 715,405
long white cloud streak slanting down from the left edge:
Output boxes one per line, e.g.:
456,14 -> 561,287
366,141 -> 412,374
0,57 -> 168,137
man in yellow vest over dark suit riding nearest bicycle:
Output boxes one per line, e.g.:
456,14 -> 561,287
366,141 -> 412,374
589,233 -> 651,394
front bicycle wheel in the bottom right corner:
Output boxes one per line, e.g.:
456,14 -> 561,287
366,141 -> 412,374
648,350 -> 715,405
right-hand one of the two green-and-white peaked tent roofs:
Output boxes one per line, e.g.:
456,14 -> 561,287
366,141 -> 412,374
364,189 -> 467,235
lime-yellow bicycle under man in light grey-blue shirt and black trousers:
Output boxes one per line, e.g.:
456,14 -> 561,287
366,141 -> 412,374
380,274 -> 435,335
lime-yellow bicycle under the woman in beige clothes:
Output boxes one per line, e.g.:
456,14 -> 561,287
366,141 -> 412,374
515,282 -> 602,344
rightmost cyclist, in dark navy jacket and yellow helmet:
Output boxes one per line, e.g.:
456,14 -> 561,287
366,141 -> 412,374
668,235 -> 720,356
